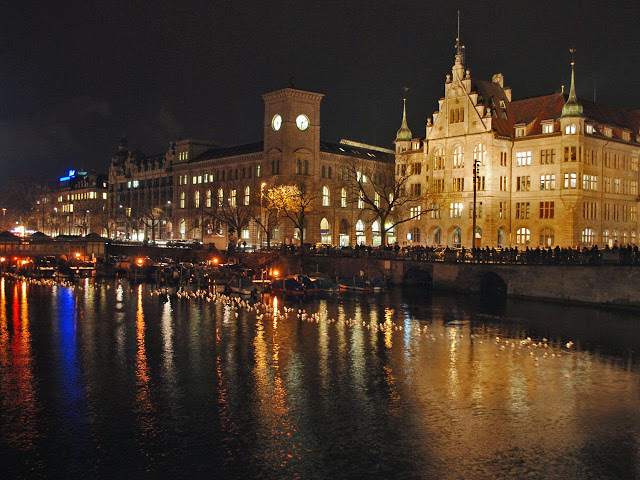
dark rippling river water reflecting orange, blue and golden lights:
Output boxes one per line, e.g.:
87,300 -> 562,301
0,278 -> 640,479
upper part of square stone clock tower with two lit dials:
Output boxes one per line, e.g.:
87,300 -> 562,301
262,88 -> 324,177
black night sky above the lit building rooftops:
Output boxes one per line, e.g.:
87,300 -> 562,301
0,0 -> 640,186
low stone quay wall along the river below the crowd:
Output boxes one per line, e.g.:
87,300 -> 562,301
279,256 -> 640,309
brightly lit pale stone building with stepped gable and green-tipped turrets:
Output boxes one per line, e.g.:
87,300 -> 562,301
395,48 -> 640,248
